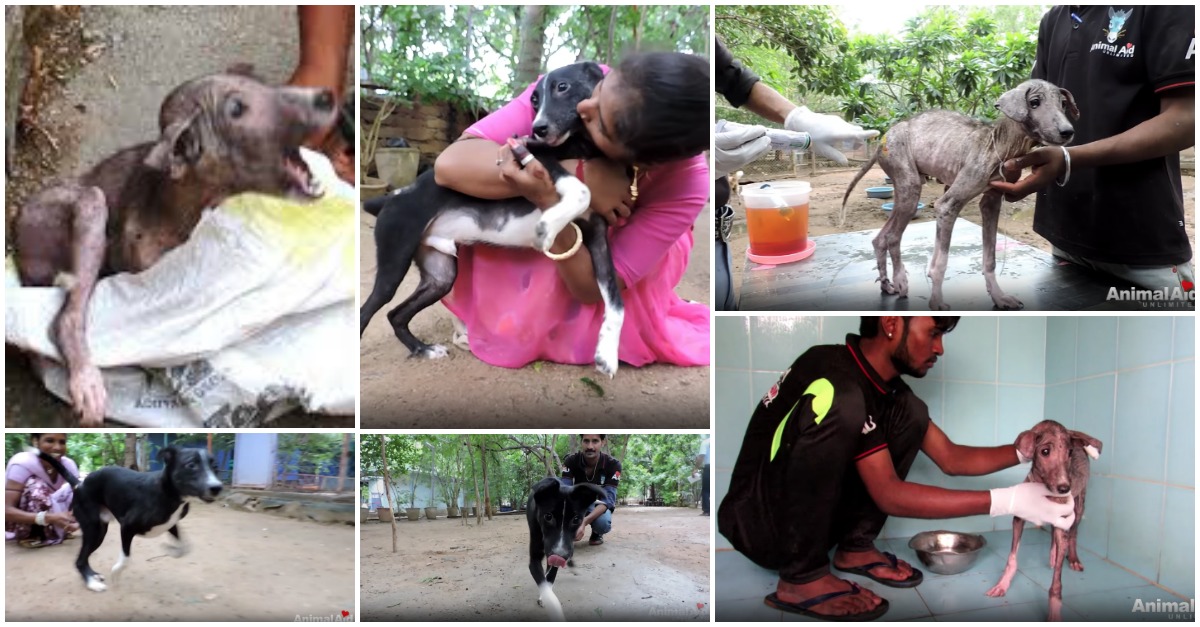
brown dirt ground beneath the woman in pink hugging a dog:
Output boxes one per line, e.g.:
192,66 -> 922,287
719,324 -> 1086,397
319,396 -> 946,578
359,209 -> 713,429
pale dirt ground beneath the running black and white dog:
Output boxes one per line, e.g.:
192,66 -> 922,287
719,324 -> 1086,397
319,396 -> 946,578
5,501 -> 355,622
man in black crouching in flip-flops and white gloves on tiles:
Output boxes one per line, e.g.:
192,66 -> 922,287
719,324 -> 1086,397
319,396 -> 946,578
718,317 -> 1075,620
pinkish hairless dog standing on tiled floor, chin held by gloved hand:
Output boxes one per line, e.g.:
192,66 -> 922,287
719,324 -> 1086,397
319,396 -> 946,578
988,420 -> 1104,621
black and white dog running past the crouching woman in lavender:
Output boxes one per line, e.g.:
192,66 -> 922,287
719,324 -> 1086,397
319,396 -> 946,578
40,447 -> 221,592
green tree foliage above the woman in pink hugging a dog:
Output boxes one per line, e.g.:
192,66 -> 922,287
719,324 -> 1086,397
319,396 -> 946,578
359,5 -> 709,111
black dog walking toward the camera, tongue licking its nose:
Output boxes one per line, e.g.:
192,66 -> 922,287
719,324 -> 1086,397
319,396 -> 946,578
526,477 -> 604,621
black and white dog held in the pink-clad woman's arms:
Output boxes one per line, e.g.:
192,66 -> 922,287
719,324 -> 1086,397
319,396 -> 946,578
359,62 -> 625,377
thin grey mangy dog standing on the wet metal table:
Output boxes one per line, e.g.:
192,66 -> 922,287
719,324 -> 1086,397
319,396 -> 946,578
841,79 -> 1079,311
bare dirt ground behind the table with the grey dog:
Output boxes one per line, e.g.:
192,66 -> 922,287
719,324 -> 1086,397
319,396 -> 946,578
730,166 -> 1196,300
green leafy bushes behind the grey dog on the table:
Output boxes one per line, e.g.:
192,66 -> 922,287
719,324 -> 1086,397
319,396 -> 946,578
716,6 -> 1044,130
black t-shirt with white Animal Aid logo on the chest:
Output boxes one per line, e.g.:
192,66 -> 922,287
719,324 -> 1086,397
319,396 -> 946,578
1033,6 -> 1195,265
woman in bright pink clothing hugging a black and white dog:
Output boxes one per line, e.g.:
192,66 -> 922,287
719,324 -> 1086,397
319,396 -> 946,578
434,53 -> 710,368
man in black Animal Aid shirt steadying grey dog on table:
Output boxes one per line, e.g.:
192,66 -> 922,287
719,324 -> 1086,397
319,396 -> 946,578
992,5 -> 1195,292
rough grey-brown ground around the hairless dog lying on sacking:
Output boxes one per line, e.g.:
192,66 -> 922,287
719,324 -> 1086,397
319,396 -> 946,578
5,6 -> 346,428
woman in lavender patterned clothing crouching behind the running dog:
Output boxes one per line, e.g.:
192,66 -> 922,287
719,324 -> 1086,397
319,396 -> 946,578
5,434 -> 79,548
